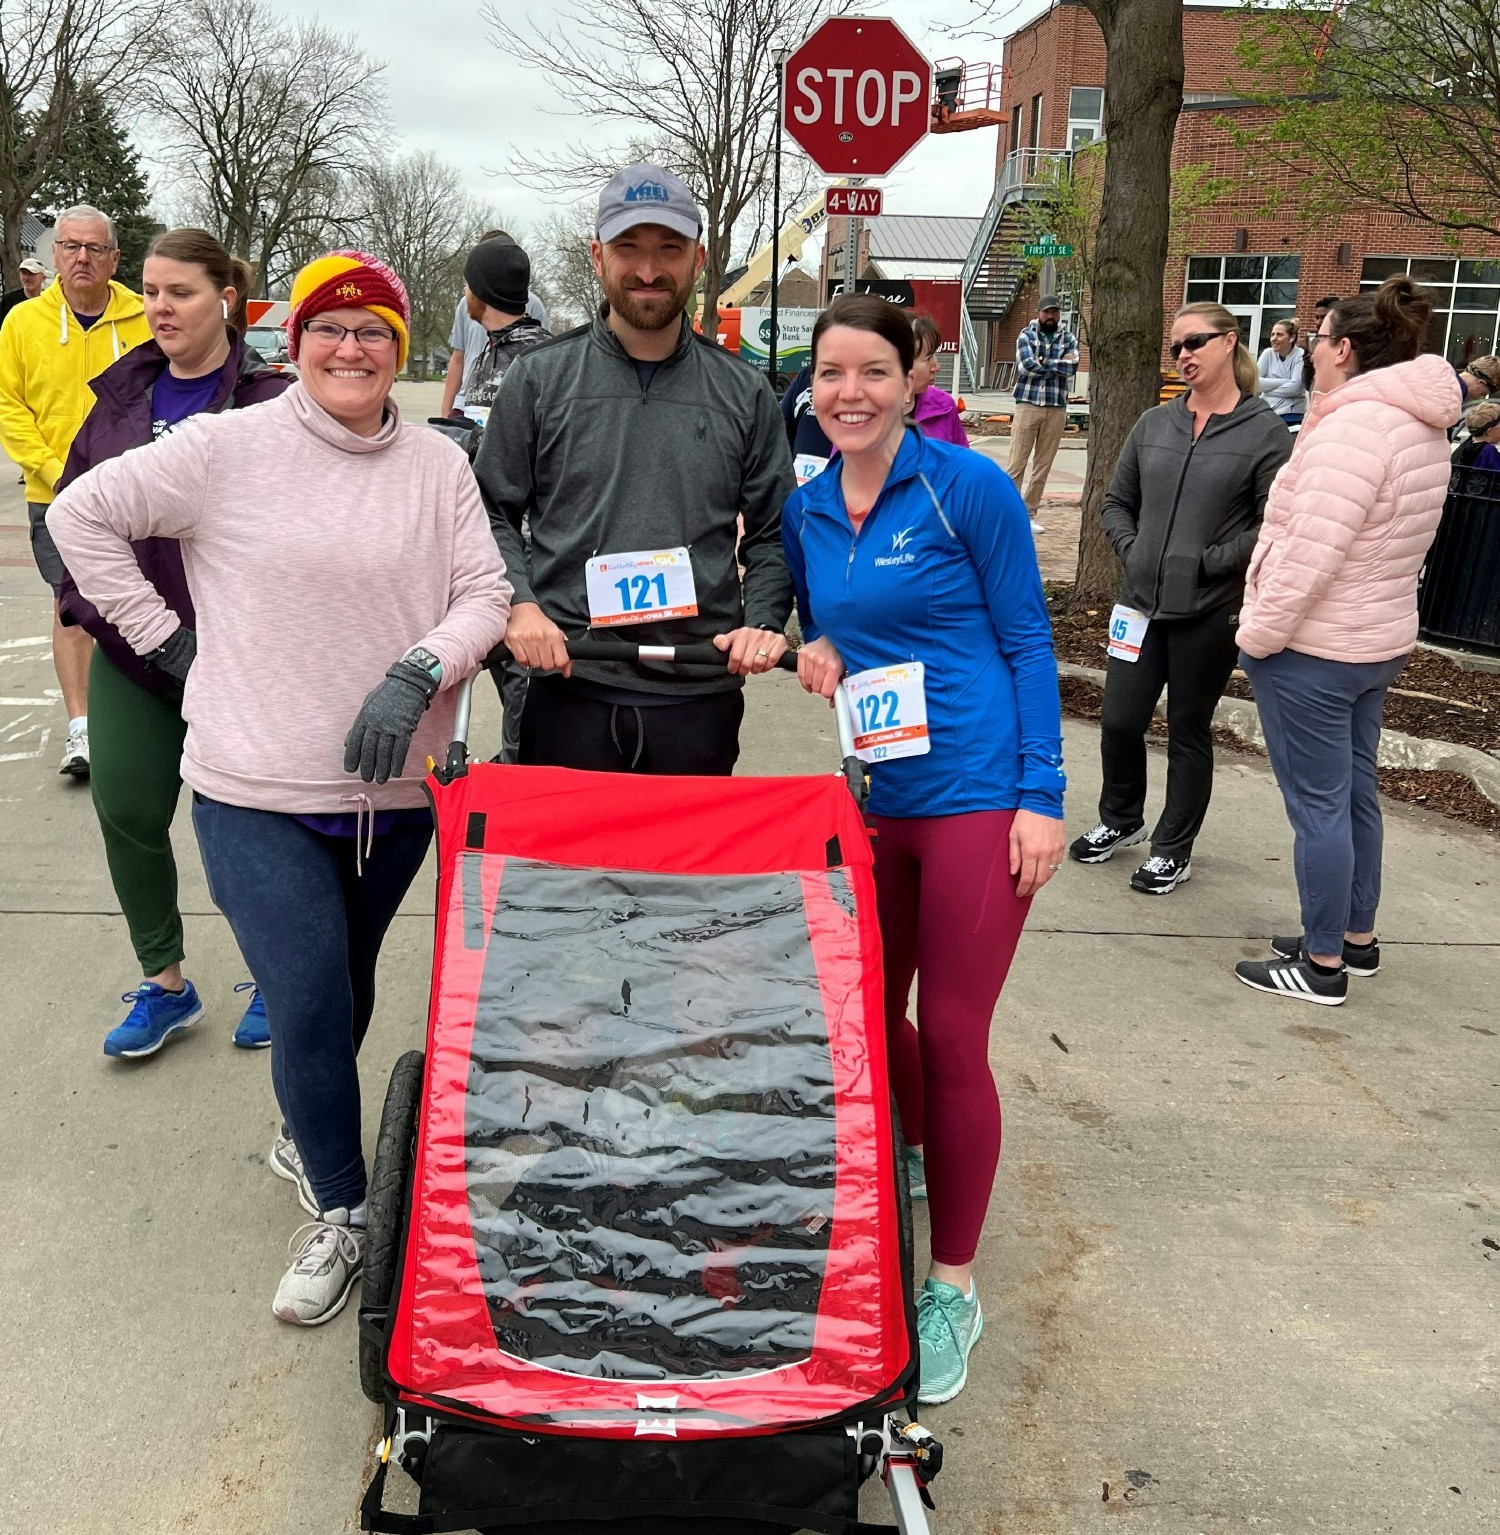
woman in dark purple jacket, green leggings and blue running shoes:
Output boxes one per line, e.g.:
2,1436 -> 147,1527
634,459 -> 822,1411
57,229 -> 292,1059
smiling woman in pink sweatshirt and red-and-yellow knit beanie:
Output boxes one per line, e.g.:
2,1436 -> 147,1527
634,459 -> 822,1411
48,252 -> 510,1326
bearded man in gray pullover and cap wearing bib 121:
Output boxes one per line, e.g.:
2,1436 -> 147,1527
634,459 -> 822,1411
474,164 -> 797,774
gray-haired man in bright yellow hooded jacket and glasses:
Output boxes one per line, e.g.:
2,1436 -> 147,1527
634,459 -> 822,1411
0,206 -> 150,778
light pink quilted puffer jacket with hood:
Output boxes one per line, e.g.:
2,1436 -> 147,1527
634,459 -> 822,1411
1239,355 -> 1460,662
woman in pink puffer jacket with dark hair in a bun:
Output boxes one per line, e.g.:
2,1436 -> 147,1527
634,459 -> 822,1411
1234,276 -> 1463,1005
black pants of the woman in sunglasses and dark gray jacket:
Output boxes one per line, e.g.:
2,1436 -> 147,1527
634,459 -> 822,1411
1099,608 -> 1237,858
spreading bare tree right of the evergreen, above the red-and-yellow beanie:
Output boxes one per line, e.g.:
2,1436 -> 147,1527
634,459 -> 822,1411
149,0 -> 385,290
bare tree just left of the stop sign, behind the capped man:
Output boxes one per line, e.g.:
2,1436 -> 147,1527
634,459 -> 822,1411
482,0 -> 844,335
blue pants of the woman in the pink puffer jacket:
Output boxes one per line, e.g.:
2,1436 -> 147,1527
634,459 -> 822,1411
1239,651 -> 1406,955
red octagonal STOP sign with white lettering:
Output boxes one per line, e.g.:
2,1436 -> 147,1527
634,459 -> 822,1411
783,17 -> 932,177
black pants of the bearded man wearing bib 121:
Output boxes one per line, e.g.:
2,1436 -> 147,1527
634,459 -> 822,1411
520,675 -> 745,777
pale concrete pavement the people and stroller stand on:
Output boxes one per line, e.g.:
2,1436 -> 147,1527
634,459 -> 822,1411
0,448 -> 1500,1535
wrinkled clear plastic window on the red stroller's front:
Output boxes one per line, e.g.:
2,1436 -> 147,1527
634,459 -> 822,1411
461,853 -> 835,1380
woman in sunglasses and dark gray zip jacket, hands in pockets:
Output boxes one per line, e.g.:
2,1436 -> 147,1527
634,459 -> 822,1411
1069,304 -> 1291,895
